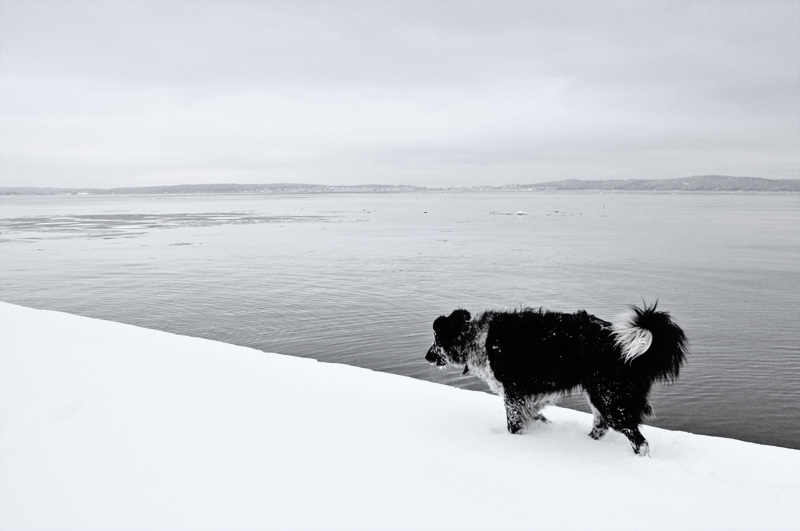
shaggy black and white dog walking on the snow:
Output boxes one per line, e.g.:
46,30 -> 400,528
425,303 -> 688,455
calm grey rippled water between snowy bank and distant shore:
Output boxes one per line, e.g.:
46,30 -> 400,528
0,192 -> 800,448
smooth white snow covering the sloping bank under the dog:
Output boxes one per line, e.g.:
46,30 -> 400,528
0,303 -> 800,530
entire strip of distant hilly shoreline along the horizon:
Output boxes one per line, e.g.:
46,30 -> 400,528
0,175 -> 800,195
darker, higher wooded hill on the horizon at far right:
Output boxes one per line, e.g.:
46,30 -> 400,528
516,175 -> 800,192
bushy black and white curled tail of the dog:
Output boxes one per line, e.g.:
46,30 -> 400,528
613,302 -> 688,382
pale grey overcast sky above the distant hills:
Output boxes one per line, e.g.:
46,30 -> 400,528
0,0 -> 800,188
